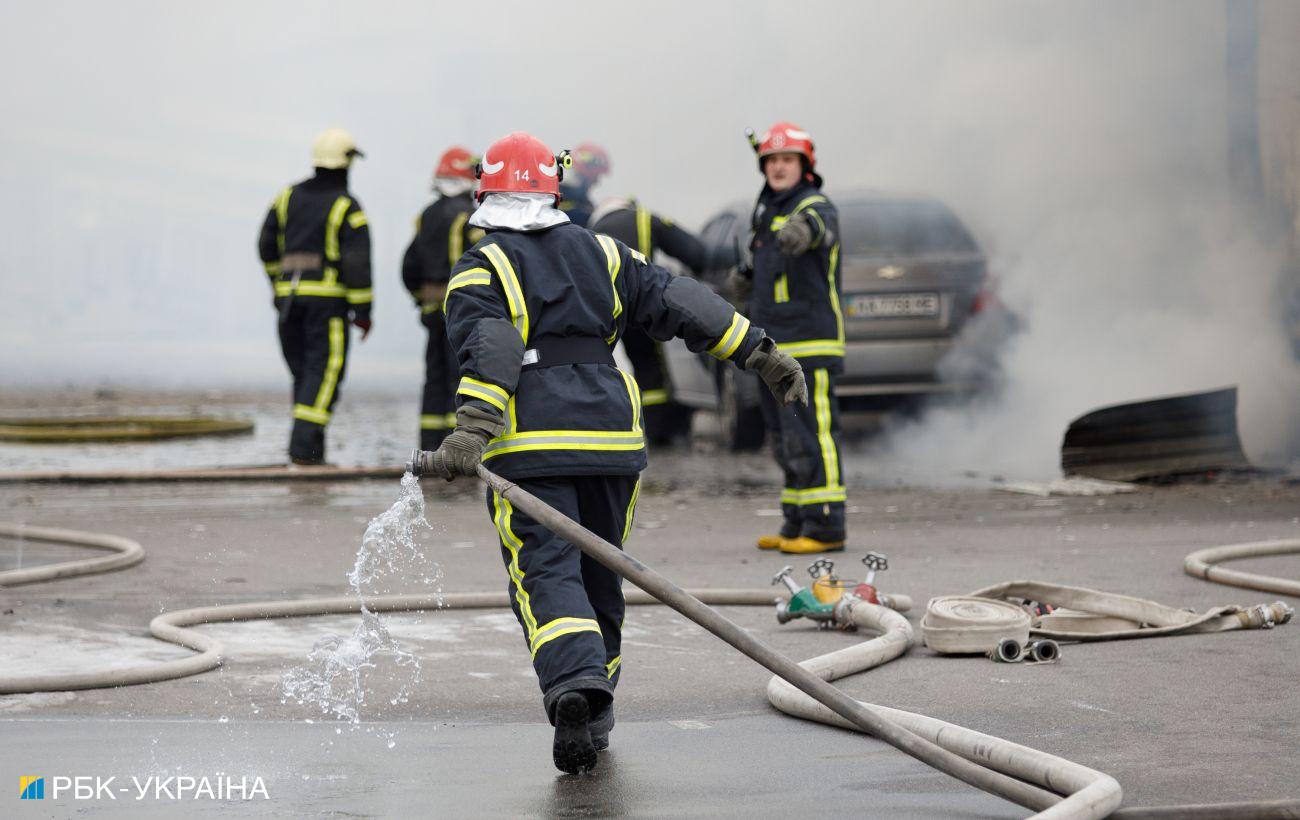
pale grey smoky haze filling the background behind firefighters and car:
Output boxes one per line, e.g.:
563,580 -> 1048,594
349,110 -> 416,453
0,0 -> 1300,475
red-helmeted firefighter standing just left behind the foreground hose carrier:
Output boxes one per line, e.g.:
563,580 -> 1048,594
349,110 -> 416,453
402,146 -> 484,450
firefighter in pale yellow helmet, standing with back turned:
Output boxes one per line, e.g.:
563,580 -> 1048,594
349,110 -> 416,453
257,129 -> 372,464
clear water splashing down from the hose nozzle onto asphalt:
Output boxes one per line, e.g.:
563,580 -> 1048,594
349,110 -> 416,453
281,473 -> 442,749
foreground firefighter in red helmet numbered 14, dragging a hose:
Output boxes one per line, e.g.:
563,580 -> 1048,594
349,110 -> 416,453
412,133 -> 807,773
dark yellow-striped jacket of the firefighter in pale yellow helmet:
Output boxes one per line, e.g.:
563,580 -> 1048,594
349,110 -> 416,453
257,168 -> 373,321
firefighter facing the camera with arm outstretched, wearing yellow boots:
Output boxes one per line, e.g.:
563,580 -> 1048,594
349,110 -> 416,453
737,122 -> 845,554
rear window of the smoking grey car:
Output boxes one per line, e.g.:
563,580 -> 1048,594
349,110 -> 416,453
840,200 -> 979,255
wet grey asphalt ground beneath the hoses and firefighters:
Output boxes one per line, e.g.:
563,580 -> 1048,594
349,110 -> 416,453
0,454 -> 1300,817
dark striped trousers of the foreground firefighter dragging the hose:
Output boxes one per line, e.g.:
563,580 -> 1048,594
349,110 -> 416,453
488,476 -> 641,734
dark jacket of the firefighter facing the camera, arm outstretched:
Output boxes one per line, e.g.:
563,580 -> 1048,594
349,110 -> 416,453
750,182 -> 844,372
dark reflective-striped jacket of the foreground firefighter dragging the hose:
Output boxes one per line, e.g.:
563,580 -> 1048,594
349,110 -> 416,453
445,224 -> 763,478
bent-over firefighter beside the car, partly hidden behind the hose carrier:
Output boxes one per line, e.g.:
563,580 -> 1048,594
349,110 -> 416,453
589,199 -> 707,444
